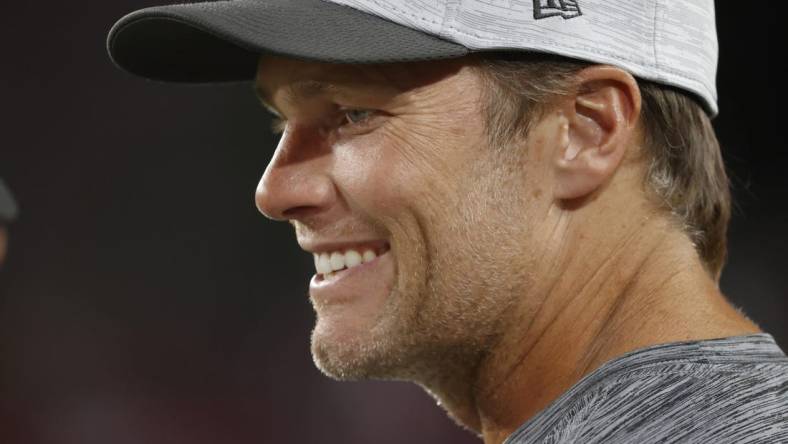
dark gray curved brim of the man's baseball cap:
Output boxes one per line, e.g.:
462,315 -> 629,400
107,0 -> 468,83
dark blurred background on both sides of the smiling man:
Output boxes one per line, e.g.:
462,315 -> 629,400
0,0 -> 788,444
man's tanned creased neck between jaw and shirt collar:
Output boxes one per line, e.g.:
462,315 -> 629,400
428,204 -> 760,444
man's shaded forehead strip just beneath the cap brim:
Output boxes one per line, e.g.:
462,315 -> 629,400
255,56 -> 469,104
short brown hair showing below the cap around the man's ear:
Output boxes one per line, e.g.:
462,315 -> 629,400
470,52 -> 731,280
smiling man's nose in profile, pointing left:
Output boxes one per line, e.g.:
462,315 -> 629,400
255,125 -> 335,220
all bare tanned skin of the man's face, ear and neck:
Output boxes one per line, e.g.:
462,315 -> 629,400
256,57 -> 760,443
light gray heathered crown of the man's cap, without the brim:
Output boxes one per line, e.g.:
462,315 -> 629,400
332,0 -> 718,115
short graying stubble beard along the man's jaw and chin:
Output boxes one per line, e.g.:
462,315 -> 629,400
311,153 -> 526,387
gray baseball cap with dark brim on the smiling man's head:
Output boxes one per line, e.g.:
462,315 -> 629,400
108,0 -> 718,116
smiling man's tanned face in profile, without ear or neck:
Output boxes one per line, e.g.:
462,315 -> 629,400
256,58 -> 544,379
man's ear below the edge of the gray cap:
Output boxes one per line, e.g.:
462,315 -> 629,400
553,66 -> 641,200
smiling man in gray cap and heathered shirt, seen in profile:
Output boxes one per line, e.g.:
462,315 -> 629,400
109,0 -> 788,443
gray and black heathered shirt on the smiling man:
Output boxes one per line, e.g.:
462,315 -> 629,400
505,333 -> 788,444
